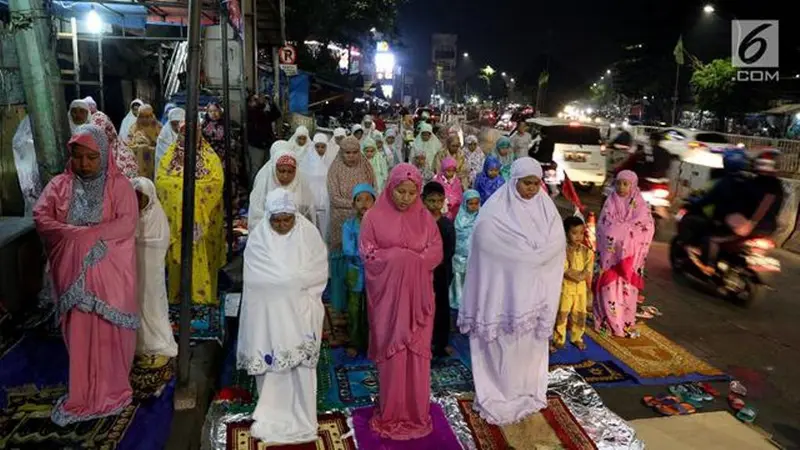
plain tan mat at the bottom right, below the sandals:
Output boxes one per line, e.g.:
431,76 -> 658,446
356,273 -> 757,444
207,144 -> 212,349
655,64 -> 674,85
629,411 -> 776,450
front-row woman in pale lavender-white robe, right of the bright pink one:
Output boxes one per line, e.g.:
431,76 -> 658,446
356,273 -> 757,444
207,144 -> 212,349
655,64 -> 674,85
458,156 -> 566,425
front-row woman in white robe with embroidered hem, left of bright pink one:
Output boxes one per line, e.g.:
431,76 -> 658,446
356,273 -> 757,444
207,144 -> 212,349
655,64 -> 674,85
237,188 -> 328,445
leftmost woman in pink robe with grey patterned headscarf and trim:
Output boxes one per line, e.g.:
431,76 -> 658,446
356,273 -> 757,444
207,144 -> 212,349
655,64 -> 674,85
33,125 -> 139,426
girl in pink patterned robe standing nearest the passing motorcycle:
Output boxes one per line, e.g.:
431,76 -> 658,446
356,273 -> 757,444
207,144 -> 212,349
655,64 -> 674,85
592,170 -> 655,337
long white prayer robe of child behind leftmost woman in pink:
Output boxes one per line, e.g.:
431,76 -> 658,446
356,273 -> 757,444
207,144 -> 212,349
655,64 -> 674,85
131,177 -> 178,357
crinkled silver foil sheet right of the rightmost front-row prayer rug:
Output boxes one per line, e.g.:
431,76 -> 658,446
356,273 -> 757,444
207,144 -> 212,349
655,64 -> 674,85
547,368 -> 644,450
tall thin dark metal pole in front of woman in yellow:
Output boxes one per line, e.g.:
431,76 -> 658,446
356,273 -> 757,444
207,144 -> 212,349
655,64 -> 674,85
175,0 -> 203,410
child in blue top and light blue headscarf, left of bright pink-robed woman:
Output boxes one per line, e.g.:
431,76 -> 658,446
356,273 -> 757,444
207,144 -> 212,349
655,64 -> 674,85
342,183 -> 376,358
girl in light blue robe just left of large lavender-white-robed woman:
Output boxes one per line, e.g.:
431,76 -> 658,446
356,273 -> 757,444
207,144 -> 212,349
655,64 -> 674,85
450,189 -> 481,310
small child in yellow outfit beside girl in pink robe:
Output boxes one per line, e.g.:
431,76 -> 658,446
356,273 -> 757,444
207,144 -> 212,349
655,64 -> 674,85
550,216 -> 594,352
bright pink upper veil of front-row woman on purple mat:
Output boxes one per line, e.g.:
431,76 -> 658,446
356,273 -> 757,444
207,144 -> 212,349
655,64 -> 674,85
359,163 -> 442,363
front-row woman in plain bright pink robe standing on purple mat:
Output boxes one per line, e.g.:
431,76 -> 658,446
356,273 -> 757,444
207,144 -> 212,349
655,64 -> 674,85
359,163 -> 442,440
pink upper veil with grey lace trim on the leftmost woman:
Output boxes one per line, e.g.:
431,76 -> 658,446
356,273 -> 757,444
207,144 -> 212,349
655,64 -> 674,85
33,125 -> 139,329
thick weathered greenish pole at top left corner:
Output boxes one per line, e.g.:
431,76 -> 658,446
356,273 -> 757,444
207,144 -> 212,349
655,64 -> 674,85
8,0 -> 69,186
